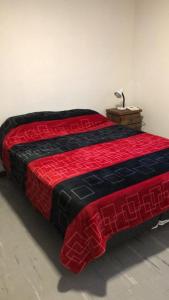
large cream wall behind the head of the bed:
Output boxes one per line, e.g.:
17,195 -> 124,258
0,0 -> 134,123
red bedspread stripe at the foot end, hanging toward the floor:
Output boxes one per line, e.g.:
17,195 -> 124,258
61,173 -> 169,272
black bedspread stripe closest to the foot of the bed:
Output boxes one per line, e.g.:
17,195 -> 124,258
51,148 -> 169,234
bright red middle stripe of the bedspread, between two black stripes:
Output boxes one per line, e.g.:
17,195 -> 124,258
26,133 -> 169,219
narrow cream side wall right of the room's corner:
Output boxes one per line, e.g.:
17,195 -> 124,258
134,0 -> 169,137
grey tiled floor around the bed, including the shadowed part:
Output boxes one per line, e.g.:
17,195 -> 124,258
0,178 -> 169,300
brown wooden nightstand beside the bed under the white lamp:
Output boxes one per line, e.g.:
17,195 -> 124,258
106,108 -> 143,130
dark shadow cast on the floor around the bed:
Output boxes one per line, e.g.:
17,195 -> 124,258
0,178 -> 169,297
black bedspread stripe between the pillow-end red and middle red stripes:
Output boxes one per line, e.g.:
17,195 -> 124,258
10,125 -> 142,186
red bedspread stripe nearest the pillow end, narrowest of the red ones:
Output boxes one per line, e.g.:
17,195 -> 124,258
2,114 -> 115,170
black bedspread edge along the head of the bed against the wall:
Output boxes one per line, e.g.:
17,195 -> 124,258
0,109 -> 97,154
